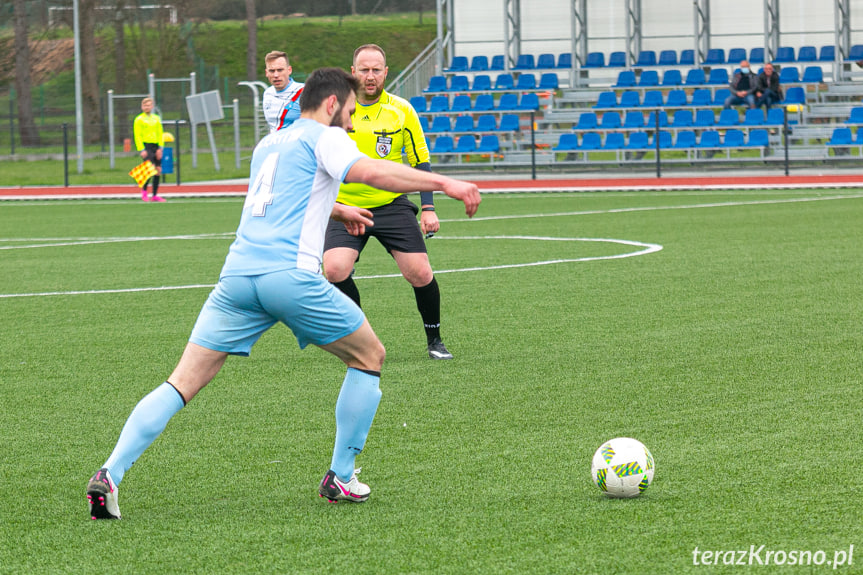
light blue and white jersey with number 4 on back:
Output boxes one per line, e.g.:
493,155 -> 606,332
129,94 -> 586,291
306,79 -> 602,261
220,119 -> 365,277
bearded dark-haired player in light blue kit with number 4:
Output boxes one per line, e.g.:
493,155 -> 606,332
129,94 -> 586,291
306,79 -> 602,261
87,68 -> 480,519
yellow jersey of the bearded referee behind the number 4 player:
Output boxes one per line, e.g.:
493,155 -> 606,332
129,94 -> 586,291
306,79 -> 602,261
337,91 -> 429,208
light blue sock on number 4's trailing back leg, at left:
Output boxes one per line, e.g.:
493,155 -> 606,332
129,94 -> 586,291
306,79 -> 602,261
103,382 -> 185,485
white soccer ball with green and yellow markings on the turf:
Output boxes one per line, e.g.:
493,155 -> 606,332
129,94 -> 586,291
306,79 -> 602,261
590,437 -> 656,498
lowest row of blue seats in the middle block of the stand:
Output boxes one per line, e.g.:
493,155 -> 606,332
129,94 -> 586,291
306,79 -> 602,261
552,129 -> 770,152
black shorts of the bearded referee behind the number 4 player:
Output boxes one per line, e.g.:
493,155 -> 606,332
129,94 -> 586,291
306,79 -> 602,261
324,196 -> 427,260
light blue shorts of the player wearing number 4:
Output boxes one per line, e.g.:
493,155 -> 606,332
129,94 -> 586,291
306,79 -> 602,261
189,269 -> 365,356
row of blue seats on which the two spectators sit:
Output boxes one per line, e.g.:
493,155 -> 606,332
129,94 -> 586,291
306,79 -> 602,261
613,66 -> 824,88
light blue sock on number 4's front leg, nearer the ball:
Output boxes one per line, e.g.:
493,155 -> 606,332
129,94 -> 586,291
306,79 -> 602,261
330,368 -> 381,481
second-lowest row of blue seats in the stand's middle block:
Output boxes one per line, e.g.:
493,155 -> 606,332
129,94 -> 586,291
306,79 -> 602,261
573,108 -> 785,131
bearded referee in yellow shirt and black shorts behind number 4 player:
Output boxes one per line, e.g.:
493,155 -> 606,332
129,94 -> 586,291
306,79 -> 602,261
323,44 -> 452,359
